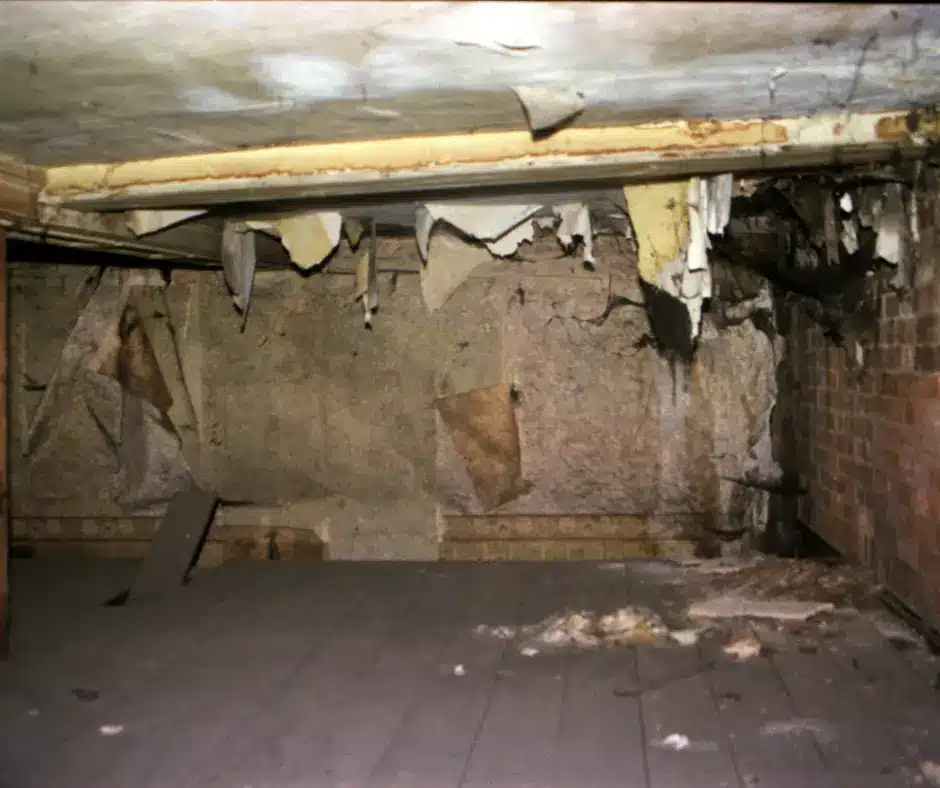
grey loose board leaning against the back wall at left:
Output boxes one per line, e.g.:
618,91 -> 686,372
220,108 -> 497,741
128,487 -> 218,599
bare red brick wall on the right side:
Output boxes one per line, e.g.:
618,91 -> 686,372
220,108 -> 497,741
778,182 -> 940,623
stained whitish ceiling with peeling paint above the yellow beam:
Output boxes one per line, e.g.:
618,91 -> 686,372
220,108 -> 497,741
0,0 -> 940,166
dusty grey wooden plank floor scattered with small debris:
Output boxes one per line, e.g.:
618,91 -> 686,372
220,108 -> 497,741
0,561 -> 940,788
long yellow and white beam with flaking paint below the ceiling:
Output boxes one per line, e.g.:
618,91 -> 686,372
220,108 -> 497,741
40,112 -> 938,210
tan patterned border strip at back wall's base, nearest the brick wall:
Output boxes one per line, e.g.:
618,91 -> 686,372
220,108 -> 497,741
441,515 -> 703,561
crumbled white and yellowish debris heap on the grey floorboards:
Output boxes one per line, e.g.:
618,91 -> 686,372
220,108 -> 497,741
476,607 -> 670,653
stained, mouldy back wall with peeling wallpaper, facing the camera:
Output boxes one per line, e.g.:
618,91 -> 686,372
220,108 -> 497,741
12,237 -> 776,559
